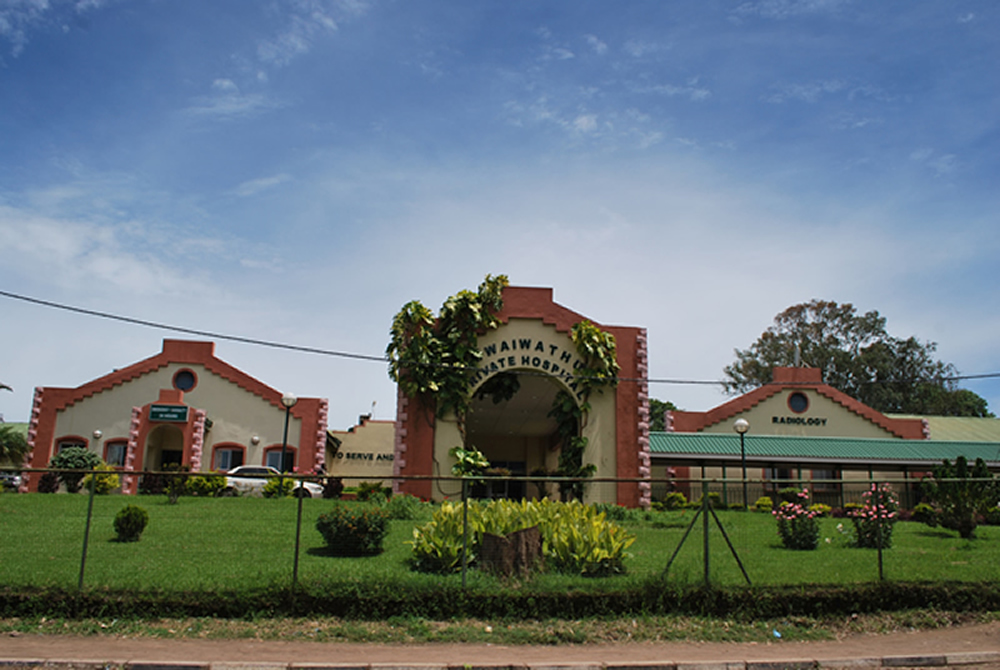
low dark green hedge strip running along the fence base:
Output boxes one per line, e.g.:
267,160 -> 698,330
0,581 -> 1000,621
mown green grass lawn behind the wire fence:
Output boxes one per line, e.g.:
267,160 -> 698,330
0,494 -> 1000,592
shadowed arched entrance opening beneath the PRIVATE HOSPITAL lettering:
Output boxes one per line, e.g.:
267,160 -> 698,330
466,371 -> 562,500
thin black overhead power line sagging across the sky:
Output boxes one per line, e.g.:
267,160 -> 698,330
0,290 -> 1000,386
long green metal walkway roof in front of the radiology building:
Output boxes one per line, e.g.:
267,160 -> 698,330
649,432 -> 1000,467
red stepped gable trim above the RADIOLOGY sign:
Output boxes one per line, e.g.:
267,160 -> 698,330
670,368 -> 927,440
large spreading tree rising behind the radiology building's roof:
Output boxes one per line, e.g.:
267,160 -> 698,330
723,300 -> 993,416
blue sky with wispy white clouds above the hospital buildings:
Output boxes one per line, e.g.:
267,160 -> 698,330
0,0 -> 1000,429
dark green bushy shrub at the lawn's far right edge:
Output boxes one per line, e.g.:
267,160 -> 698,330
923,456 -> 1000,540
